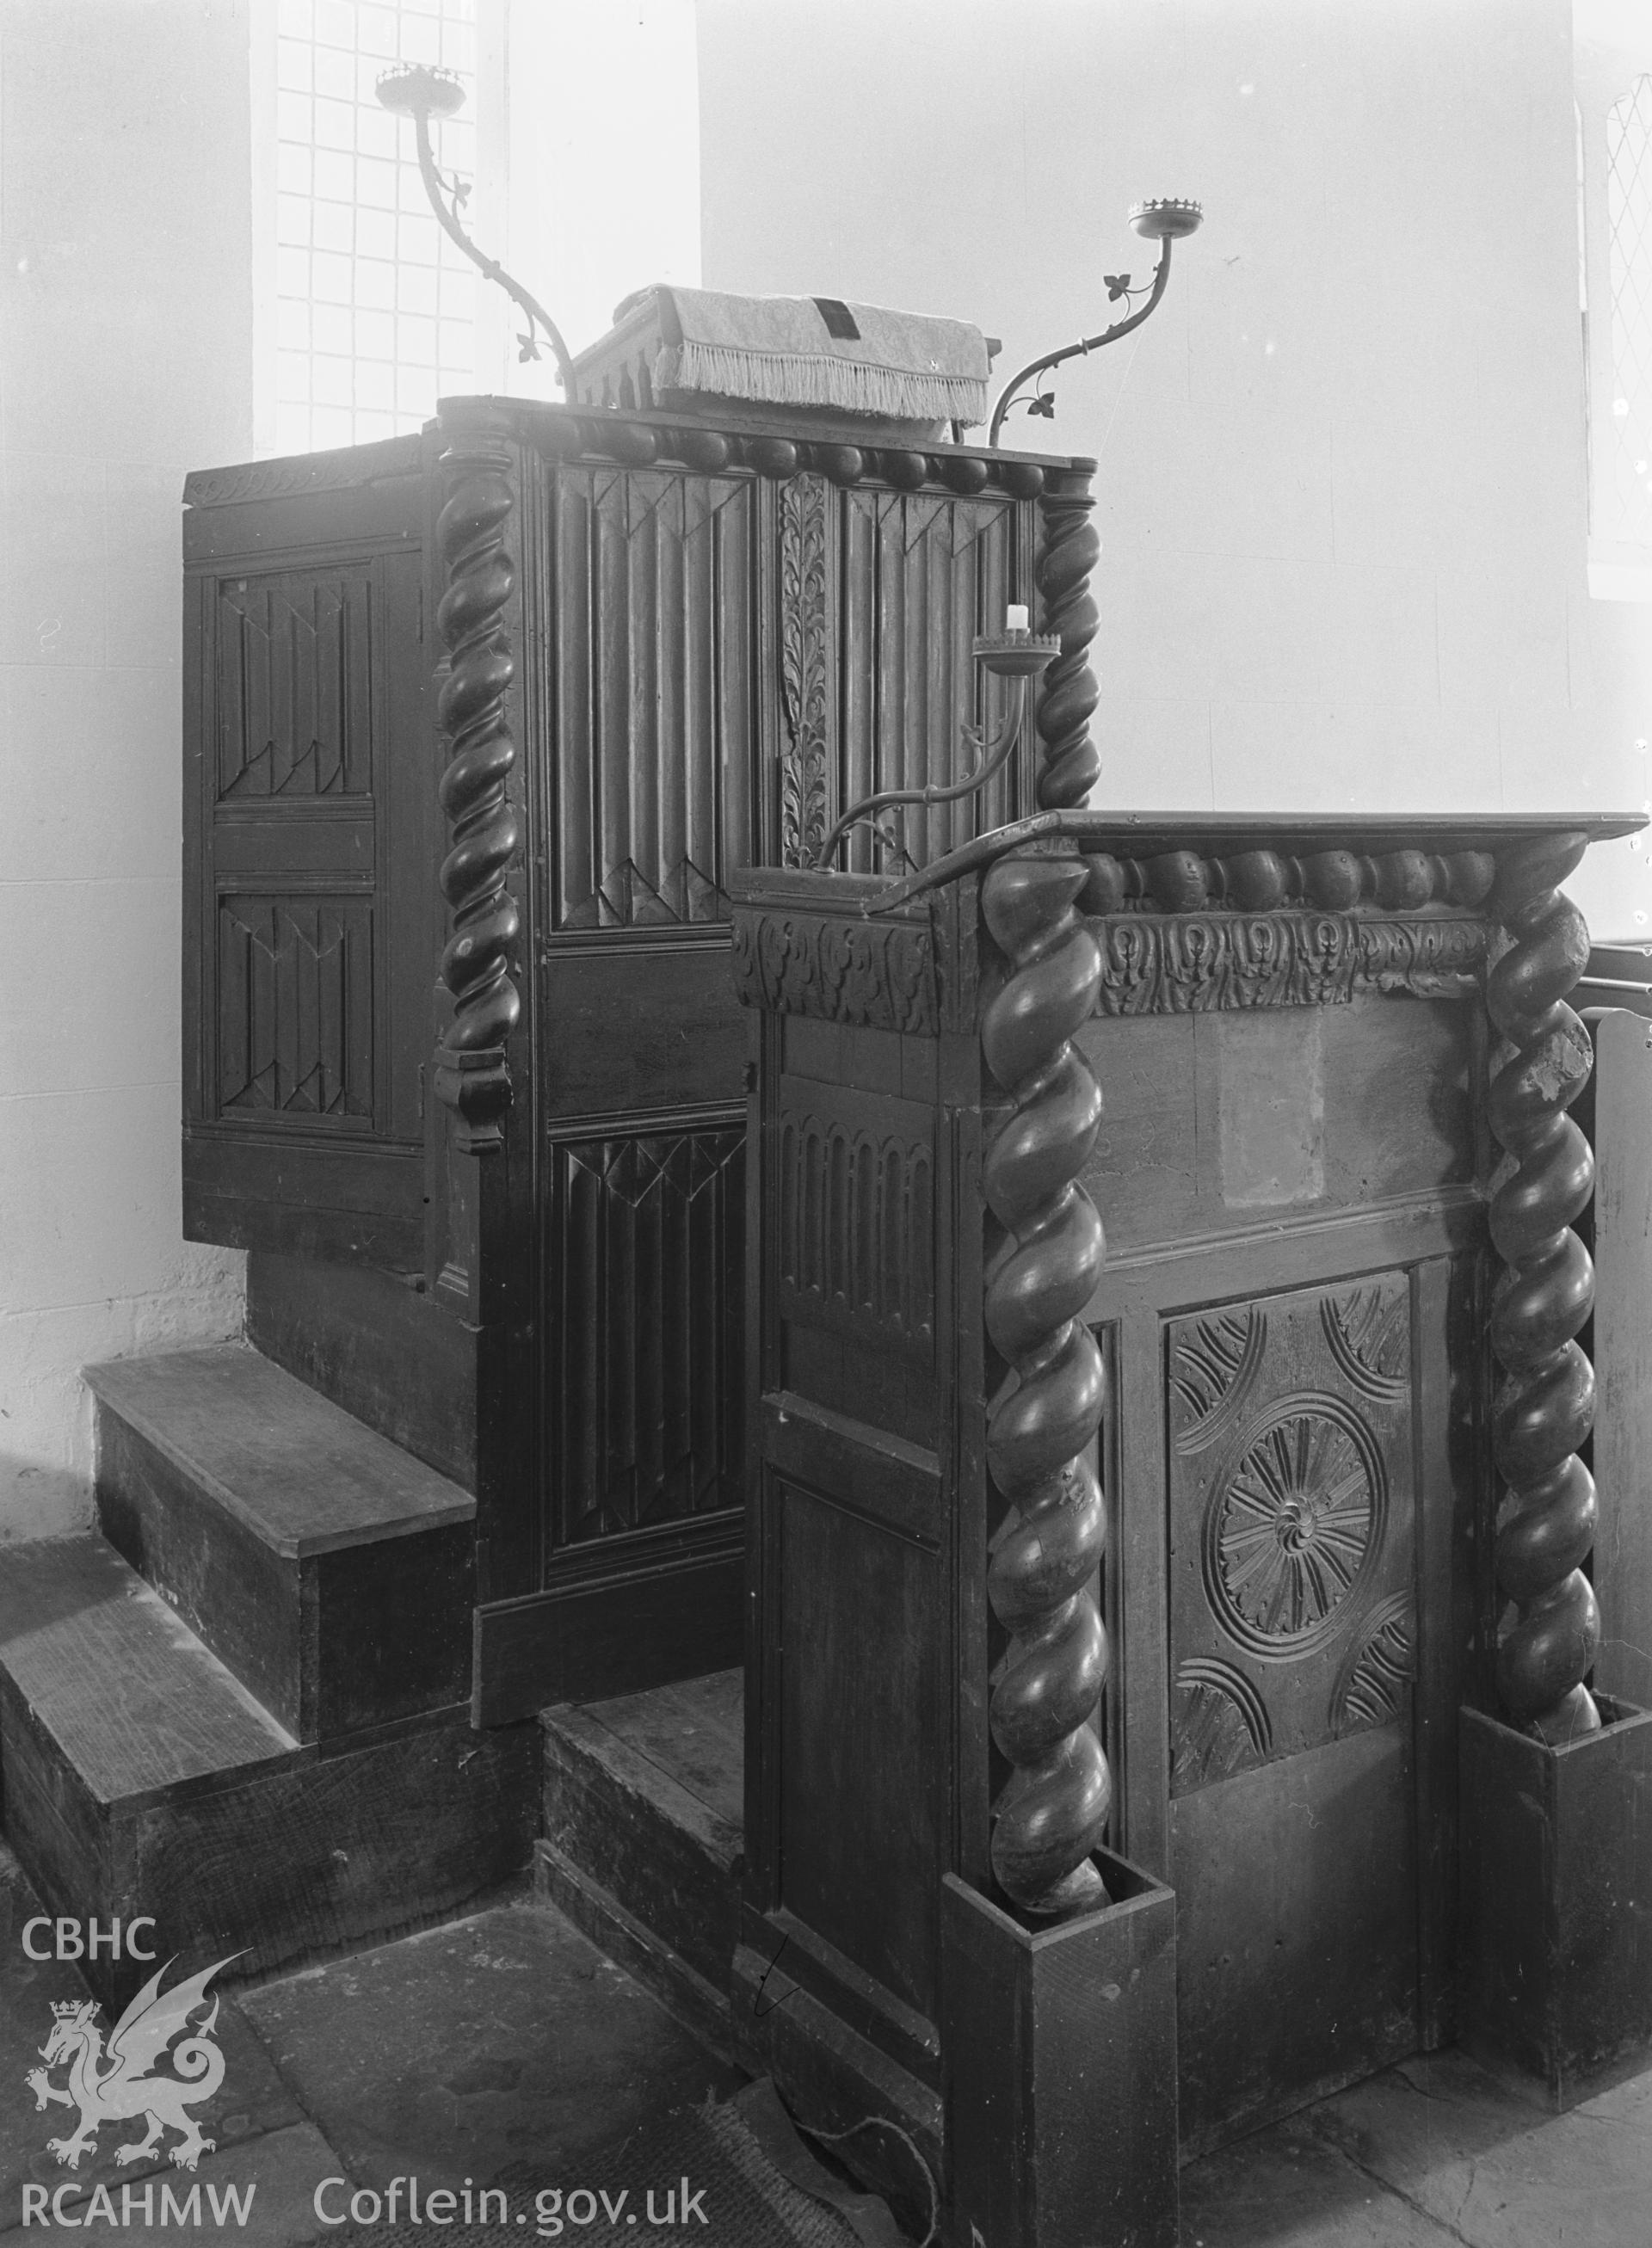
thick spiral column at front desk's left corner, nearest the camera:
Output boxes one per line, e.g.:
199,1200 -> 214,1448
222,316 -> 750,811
980,854 -> 1113,1918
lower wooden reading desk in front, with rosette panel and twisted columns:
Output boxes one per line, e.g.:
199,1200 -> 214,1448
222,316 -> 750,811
735,811 -> 1652,2248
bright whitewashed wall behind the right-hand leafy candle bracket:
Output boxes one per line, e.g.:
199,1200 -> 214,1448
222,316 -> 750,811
699,0 -> 1652,928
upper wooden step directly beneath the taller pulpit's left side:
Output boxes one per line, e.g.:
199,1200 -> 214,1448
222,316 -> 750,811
85,1345 -> 477,1740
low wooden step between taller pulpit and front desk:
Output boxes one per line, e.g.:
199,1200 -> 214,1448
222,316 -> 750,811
537,1670 -> 744,2043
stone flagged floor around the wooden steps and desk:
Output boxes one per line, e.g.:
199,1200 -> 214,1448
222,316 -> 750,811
0,1844 -> 1652,2248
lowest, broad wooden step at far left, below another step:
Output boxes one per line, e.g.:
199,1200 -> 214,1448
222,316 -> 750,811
0,1536 -> 537,2005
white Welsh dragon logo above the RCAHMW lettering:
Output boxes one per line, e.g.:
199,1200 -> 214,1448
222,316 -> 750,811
25,1951 -> 241,2170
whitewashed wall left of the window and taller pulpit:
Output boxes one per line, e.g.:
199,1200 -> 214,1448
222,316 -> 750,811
0,0 -> 252,1540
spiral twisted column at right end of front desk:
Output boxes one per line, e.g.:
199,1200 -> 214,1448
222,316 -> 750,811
1486,834 -> 1600,1742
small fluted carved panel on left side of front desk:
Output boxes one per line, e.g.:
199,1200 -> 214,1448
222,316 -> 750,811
775,1079 -> 935,1360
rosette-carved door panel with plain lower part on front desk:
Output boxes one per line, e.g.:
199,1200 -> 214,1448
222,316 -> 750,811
1164,1272 -> 1418,2145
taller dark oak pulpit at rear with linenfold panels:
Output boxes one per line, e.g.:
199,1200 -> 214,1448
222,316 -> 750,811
184,400 -> 1065,1717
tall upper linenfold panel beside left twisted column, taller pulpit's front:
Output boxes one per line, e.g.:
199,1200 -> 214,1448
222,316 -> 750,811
551,468 -> 757,928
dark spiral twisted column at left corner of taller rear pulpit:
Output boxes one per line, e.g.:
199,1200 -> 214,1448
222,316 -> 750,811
436,429 -> 521,1155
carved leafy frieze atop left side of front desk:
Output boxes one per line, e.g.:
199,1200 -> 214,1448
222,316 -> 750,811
733,908 -> 940,1037
